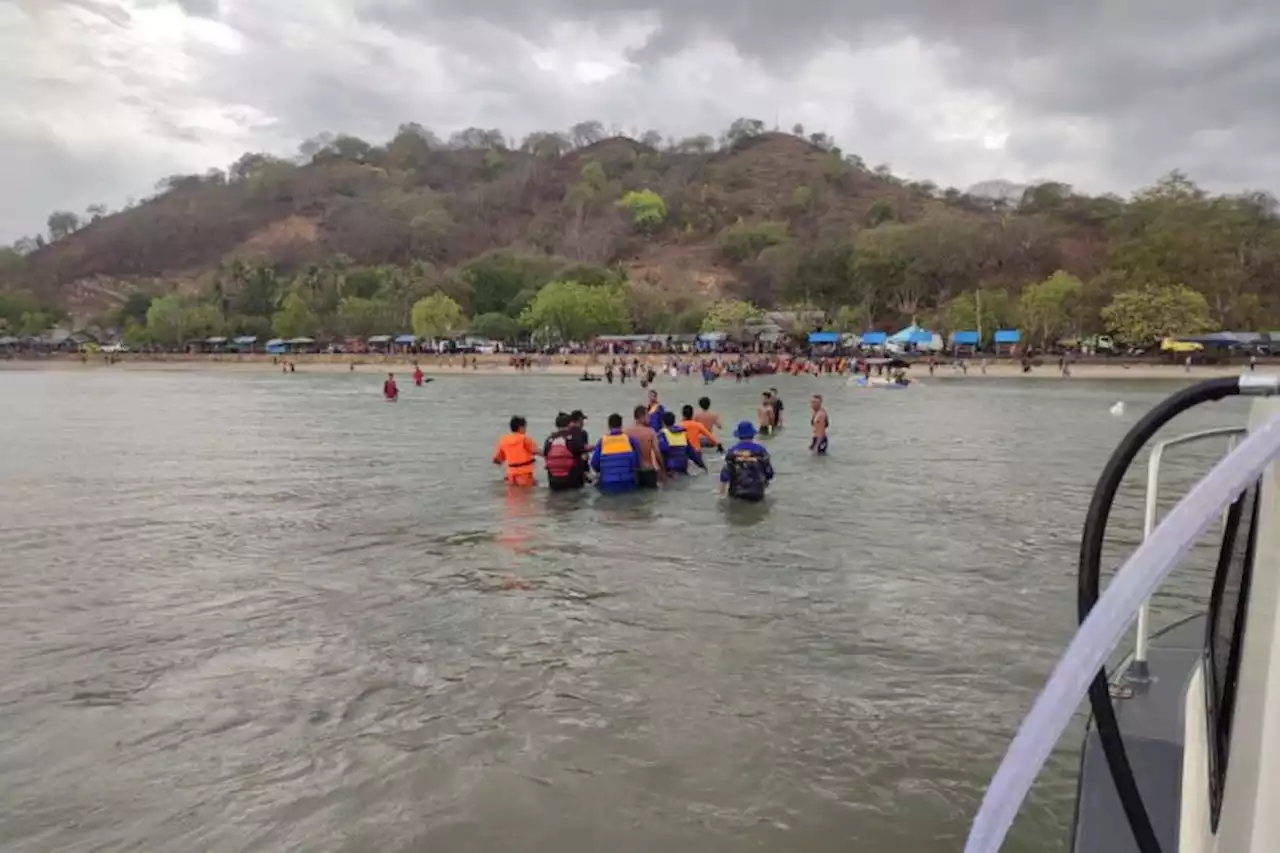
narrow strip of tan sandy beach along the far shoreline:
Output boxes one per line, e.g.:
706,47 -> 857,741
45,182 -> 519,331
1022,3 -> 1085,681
0,353 -> 1264,382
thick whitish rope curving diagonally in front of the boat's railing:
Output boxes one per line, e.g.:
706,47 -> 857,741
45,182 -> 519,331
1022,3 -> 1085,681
964,416 -> 1280,853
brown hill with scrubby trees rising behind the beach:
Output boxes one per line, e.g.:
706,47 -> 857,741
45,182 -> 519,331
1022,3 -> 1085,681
0,119 -> 1280,345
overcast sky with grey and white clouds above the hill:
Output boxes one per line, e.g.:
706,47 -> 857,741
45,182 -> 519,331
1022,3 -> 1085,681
0,0 -> 1280,242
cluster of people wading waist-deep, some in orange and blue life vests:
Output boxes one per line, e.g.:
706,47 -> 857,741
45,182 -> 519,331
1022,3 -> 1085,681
493,388 -> 828,503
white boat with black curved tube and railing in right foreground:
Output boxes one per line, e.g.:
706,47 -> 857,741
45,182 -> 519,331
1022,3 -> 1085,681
964,374 -> 1280,853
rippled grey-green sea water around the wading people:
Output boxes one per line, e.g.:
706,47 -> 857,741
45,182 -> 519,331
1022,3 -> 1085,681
0,369 -> 1243,853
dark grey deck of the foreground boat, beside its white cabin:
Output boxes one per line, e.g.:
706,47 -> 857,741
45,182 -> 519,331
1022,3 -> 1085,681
1073,616 -> 1206,853
